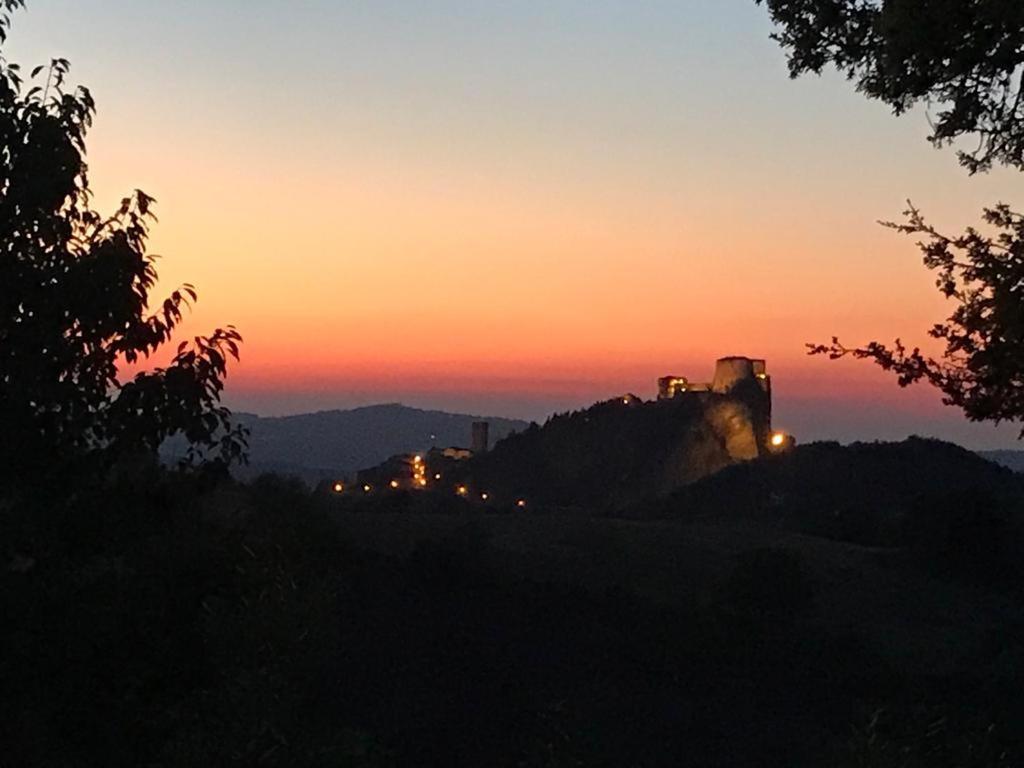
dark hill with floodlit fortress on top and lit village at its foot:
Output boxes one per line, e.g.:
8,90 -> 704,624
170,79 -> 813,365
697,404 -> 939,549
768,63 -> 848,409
330,356 -> 794,508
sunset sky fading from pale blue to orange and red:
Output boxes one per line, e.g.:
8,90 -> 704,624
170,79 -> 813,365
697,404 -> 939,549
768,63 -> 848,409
7,0 -> 1024,447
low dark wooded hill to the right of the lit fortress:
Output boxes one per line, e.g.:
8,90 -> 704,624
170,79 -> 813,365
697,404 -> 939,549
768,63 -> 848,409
630,437 -> 1024,545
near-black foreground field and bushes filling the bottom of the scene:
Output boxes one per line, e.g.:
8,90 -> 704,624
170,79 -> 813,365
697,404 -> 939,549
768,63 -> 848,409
6,441 -> 1024,766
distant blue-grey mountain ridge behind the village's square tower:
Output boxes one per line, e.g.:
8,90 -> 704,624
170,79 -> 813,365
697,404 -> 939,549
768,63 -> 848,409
208,402 -> 529,482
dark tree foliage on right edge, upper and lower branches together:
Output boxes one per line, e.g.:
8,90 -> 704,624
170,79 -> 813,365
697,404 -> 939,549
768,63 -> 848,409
757,0 -> 1024,436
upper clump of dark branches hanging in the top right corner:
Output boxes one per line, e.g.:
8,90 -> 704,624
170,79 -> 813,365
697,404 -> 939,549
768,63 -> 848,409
757,0 -> 1024,173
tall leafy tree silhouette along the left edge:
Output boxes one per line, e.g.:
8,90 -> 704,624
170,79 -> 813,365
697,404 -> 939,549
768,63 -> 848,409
0,0 -> 245,487
